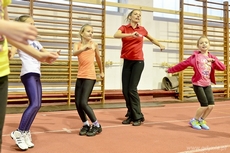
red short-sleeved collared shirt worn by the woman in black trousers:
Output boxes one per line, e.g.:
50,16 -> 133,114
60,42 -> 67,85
119,24 -> 148,60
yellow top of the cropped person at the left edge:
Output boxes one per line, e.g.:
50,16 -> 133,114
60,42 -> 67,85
0,0 -> 11,77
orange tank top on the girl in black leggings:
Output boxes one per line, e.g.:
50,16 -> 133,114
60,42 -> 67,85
77,43 -> 96,80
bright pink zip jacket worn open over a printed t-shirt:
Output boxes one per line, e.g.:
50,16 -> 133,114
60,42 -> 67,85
168,51 -> 226,84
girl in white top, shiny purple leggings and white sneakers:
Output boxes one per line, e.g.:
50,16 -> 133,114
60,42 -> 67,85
11,15 -> 60,150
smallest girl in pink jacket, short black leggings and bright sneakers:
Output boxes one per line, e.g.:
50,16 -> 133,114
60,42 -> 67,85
166,36 -> 226,130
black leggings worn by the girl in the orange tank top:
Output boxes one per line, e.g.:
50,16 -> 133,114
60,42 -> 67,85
75,78 -> 97,122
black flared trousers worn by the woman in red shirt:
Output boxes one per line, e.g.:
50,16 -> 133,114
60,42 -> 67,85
122,59 -> 144,120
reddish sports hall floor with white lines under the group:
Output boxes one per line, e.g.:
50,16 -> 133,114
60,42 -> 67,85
2,101 -> 230,153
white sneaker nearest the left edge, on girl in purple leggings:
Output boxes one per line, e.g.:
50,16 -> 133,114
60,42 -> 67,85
10,130 -> 28,150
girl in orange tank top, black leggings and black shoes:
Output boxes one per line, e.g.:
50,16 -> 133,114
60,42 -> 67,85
73,24 -> 104,136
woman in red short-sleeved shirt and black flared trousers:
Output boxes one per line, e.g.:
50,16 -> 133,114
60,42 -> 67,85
114,10 -> 165,126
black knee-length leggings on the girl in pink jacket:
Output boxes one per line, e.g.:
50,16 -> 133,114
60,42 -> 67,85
193,85 -> 214,107
